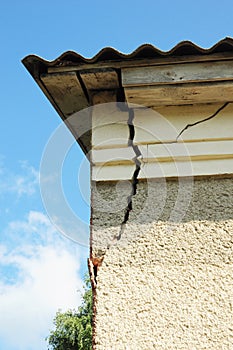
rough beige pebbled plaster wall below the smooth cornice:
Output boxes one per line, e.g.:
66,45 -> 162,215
92,179 -> 233,350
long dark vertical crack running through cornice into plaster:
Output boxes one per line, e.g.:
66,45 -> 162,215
114,108 -> 142,241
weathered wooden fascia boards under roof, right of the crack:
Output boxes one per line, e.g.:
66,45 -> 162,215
122,59 -> 233,107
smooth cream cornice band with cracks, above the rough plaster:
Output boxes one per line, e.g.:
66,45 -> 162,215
92,103 -> 233,181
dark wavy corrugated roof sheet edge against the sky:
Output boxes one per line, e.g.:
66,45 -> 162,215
22,37 -> 233,75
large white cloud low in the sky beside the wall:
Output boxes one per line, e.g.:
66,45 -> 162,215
0,211 -> 87,350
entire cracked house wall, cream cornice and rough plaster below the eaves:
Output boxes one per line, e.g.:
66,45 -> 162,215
90,103 -> 233,350
